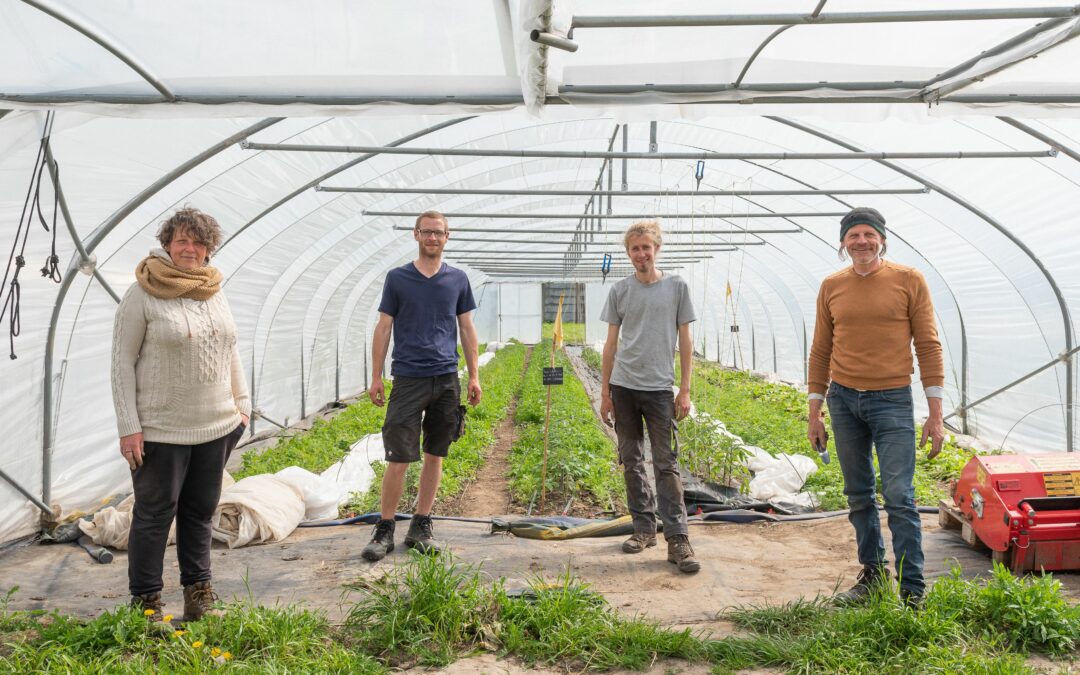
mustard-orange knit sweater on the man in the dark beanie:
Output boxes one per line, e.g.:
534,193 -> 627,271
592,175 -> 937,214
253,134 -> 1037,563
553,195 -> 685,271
809,261 -> 945,394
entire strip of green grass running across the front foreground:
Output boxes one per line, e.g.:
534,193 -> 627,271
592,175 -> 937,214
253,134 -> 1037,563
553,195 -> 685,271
0,554 -> 1080,675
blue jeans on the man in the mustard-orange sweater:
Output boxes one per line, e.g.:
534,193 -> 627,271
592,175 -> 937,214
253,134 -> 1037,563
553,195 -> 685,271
826,382 -> 926,594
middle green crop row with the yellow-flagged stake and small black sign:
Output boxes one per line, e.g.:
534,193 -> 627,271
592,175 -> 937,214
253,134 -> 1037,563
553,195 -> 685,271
510,340 -> 625,507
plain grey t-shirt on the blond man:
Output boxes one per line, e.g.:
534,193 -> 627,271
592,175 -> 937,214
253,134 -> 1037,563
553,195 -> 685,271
600,274 -> 698,391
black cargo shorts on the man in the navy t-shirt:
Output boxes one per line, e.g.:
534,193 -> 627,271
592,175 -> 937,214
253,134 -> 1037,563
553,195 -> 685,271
382,373 -> 461,462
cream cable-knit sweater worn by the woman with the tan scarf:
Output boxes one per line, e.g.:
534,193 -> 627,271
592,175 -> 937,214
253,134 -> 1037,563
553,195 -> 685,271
112,258 -> 252,445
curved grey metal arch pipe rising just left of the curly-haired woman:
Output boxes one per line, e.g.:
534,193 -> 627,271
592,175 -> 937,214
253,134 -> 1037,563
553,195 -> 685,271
41,118 -> 284,504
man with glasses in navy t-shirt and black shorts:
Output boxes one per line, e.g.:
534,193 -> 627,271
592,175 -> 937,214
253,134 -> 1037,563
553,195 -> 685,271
363,211 -> 481,561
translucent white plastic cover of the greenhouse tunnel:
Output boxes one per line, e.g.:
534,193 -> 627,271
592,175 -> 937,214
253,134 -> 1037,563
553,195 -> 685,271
0,0 -> 1080,542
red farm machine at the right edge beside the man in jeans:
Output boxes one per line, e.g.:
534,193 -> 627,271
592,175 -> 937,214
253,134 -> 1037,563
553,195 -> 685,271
940,453 -> 1080,573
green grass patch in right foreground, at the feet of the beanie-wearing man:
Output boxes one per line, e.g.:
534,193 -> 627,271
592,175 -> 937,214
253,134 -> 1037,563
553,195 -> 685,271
715,565 -> 1080,673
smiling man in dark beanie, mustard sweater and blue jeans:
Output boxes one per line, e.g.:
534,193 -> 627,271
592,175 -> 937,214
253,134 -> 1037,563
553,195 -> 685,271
807,207 -> 945,607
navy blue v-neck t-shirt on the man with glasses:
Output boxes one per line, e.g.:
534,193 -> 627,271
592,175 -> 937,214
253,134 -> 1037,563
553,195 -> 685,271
379,262 -> 476,377
